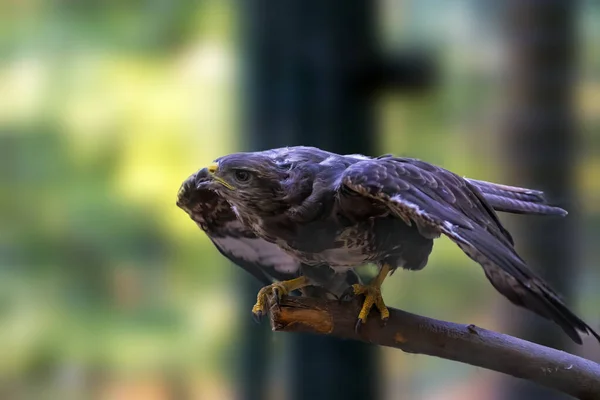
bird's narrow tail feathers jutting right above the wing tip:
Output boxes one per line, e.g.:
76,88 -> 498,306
465,178 -> 567,216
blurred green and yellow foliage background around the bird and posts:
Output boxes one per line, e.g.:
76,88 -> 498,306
0,0 -> 600,400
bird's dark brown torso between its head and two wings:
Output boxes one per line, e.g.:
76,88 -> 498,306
248,152 -> 438,269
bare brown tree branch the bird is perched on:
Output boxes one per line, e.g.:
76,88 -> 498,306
269,296 -> 600,400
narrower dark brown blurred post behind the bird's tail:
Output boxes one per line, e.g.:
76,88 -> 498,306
504,0 -> 579,400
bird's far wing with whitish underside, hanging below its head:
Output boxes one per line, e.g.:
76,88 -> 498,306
180,183 -> 300,285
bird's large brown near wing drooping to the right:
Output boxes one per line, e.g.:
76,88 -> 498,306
338,157 -> 600,343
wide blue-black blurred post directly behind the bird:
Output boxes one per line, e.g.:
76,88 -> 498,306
241,0 -> 378,400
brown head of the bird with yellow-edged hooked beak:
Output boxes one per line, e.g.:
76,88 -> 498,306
177,153 -> 289,217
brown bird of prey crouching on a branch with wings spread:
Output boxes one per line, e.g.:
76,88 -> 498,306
177,146 -> 600,344
